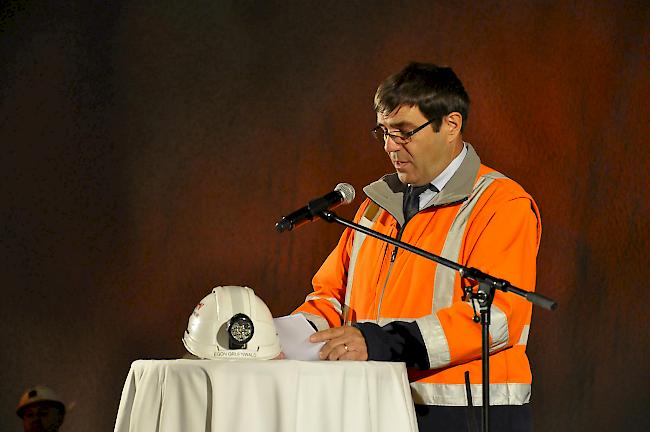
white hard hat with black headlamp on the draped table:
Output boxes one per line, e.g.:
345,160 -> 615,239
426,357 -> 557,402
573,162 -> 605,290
183,286 -> 281,360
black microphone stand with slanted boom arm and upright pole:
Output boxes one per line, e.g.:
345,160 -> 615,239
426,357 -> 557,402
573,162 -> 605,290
319,210 -> 558,432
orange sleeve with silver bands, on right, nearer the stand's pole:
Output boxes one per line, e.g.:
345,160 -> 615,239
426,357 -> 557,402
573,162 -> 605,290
415,197 -> 541,369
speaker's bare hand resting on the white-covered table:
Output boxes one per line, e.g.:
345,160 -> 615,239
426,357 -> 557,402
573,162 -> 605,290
309,326 -> 368,361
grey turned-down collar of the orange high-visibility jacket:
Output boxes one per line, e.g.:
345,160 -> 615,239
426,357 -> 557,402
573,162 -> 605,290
363,143 -> 481,226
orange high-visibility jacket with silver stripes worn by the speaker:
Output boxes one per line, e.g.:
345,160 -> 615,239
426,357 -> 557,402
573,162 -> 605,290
296,144 -> 541,406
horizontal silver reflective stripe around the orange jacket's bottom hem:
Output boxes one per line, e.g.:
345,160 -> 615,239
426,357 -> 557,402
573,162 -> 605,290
411,382 -> 530,406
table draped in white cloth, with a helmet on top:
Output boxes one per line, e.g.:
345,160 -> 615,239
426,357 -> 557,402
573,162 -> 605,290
115,360 -> 417,432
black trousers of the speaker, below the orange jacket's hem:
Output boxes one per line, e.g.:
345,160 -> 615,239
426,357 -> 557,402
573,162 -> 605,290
415,404 -> 533,432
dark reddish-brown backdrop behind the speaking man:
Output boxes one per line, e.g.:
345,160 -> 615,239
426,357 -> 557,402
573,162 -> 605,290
0,0 -> 650,431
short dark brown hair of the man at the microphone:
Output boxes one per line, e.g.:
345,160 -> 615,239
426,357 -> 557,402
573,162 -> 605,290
374,63 -> 469,132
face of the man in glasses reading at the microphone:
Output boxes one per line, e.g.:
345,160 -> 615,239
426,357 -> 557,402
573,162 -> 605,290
377,105 -> 457,186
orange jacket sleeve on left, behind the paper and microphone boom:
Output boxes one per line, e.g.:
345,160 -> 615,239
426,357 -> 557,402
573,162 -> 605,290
293,200 -> 368,330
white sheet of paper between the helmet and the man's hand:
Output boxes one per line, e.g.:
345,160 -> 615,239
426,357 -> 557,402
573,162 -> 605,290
273,314 -> 325,360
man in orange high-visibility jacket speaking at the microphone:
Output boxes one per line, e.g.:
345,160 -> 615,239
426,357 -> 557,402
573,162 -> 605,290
296,63 -> 541,432
